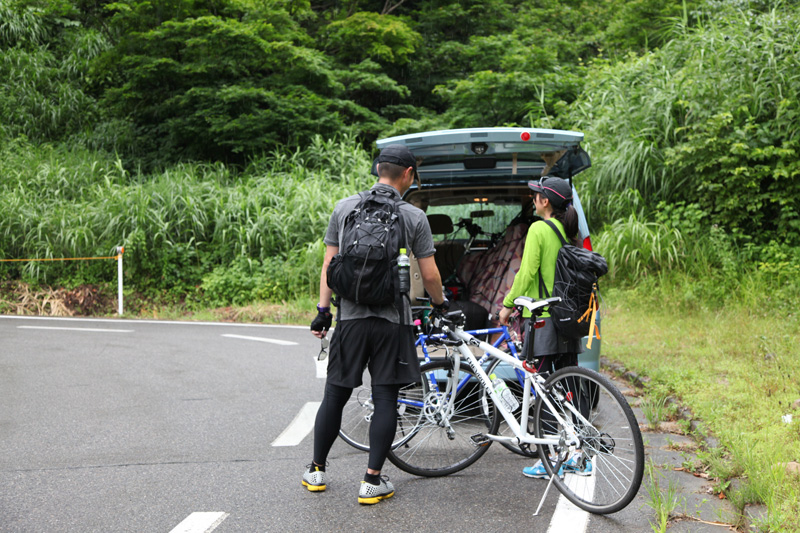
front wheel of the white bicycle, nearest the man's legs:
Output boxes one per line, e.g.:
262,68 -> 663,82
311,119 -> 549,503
389,360 -> 500,477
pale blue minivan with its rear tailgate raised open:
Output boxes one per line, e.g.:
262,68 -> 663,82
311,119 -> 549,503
377,128 -> 600,370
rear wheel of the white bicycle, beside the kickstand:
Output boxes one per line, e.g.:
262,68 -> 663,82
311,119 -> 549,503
534,366 -> 644,514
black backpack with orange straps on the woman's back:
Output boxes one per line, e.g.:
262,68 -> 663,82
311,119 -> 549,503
539,220 -> 608,339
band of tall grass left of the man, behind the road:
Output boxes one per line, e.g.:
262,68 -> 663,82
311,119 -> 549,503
0,134 -> 374,298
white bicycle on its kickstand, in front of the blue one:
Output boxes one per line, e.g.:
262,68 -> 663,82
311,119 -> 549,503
389,296 -> 645,514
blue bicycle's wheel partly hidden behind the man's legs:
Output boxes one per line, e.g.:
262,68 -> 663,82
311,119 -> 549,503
339,374 -> 422,452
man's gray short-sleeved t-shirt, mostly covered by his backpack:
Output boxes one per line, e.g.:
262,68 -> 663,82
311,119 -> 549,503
323,183 -> 436,325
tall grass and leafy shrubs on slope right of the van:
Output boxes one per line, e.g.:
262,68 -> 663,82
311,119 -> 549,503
570,3 -> 800,237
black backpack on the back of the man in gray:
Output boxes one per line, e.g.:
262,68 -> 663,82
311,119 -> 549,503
327,190 -> 406,305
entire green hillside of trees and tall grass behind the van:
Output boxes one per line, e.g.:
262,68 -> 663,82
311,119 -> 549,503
0,0 -> 800,305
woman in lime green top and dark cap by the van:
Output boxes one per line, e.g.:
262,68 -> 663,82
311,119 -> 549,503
499,177 -> 591,478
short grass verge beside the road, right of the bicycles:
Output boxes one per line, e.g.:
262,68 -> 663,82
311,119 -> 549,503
603,283 -> 800,531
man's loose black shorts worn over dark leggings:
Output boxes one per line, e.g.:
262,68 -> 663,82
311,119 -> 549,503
328,317 -> 420,388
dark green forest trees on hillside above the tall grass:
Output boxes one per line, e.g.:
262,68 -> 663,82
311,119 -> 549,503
0,0 -> 710,166
